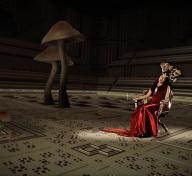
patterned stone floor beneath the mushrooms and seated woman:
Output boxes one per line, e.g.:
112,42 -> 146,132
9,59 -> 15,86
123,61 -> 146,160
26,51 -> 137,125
0,90 -> 192,176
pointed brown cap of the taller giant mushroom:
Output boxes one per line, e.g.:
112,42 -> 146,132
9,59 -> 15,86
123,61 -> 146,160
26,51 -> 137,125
41,21 -> 85,44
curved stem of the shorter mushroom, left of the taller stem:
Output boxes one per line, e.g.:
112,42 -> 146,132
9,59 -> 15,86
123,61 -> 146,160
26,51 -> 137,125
44,61 -> 58,105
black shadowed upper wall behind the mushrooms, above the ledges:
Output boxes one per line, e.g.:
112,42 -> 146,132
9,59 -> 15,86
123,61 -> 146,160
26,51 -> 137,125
0,0 -> 192,76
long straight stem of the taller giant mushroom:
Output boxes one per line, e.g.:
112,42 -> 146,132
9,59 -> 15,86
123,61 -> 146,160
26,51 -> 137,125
58,40 -> 70,108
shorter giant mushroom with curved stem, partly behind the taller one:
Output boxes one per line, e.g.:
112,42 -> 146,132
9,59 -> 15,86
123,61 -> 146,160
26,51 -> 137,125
34,45 -> 74,105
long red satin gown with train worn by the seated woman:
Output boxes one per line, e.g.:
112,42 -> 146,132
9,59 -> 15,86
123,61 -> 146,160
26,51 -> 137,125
102,83 -> 167,137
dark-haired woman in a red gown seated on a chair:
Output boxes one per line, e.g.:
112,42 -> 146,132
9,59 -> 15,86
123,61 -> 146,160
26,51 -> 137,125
102,74 -> 170,137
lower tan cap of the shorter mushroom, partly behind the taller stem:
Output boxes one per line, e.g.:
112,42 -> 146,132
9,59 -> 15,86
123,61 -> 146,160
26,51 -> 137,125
34,45 -> 74,66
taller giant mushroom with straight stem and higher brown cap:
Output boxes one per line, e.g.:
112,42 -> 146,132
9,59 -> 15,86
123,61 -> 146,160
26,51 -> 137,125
41,21 -> 84,108
